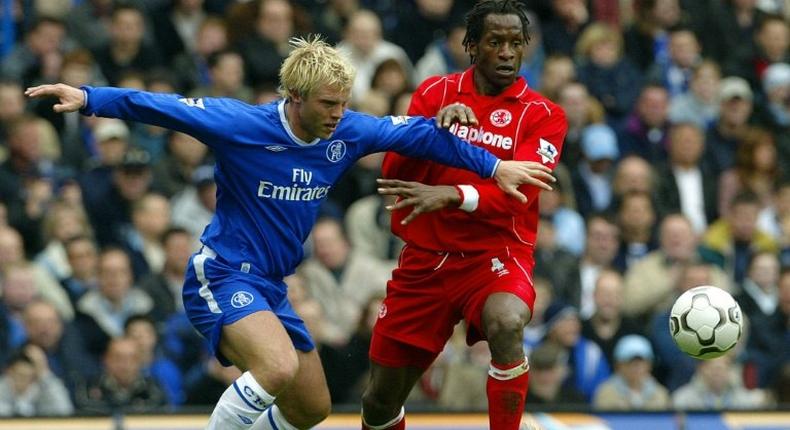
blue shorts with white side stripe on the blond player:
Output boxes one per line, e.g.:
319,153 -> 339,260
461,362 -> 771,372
182,246 -> 315,366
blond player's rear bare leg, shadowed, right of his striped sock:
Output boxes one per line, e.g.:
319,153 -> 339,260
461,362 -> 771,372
275,349 -> 332,428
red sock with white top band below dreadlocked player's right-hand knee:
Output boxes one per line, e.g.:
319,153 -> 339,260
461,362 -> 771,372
486,360 -> 529,430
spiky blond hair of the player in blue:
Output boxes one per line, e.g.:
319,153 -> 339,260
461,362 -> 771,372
278,35 -> 356,99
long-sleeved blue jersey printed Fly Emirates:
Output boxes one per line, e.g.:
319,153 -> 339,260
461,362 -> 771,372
82,87 -> 499,277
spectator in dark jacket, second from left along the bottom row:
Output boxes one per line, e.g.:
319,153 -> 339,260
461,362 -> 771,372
75,337 -> 165,414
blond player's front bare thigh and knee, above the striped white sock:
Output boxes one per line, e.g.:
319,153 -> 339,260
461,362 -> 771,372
219,311 -> 299,382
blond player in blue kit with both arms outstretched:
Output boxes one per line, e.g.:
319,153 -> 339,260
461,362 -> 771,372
26,38 -> 552,429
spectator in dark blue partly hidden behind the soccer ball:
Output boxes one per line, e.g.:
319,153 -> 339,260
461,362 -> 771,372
648,261 -> 716,391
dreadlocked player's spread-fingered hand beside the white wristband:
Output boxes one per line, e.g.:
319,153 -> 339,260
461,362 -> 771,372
377,179 -> 461,225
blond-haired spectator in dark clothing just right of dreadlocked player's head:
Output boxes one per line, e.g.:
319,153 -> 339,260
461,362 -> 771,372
576,23 -> 642,123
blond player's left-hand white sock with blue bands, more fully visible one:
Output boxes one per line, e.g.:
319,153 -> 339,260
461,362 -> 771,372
206,372 -> 274,430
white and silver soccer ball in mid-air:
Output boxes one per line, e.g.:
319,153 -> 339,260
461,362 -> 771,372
669,285 -> 743,360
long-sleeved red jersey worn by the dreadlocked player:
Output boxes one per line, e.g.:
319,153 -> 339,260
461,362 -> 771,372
383,66 -> 568,252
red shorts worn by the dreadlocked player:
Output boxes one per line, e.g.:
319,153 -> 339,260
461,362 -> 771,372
370,246 -> 535,368
